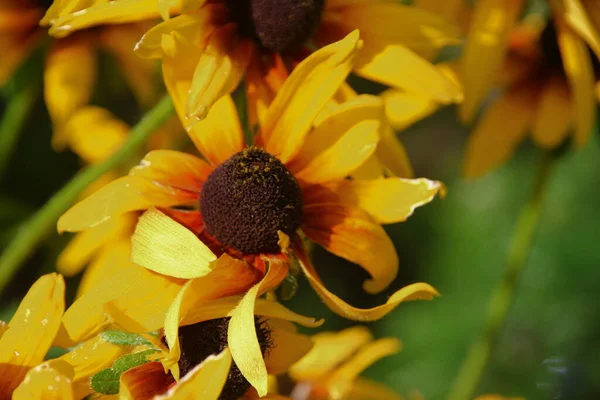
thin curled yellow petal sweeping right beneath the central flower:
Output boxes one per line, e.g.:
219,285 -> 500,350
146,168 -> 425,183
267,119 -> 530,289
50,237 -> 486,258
296,245 -> 439,321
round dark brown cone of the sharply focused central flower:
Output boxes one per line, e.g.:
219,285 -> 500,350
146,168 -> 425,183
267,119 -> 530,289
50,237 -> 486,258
200,147 -> 302,254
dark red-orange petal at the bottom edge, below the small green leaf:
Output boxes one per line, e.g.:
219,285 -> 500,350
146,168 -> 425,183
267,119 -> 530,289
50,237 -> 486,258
119,362 -> 173,400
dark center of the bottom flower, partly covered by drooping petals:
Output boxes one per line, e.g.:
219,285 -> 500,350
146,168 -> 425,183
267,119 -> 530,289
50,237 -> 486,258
173,318 -> 273,400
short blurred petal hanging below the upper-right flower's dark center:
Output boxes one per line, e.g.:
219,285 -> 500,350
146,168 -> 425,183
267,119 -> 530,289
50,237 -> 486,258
531,75 -> 573,149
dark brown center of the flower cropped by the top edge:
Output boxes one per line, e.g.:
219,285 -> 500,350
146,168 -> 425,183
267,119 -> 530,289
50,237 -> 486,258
224,0 -> 325,53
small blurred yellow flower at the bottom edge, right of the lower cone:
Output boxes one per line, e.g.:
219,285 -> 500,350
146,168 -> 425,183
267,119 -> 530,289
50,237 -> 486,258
282,326 -> 402,400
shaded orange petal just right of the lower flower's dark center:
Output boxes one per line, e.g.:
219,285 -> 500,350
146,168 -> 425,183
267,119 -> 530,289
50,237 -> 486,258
265,319 -> 313,375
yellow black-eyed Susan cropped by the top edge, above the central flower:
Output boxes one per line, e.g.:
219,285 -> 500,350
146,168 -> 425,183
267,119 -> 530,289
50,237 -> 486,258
45,0 -> 461,126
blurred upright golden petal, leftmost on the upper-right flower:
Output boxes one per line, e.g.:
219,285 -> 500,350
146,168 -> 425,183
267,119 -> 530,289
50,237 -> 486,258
460,0 -> 524,121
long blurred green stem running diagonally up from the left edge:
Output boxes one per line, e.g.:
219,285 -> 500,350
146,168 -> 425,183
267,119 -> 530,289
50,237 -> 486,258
0,96 -> 174,293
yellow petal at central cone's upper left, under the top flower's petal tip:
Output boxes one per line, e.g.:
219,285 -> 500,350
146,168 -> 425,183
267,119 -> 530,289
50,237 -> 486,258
189,95 -> 244,165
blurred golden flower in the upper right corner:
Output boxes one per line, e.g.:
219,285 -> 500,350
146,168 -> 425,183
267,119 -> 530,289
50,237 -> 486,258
461,0 -> 600,177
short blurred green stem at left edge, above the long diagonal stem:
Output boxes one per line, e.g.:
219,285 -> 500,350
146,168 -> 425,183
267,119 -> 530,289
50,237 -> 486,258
0,85 -> 38,178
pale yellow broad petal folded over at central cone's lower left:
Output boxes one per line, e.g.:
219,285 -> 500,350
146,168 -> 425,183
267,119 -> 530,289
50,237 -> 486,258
131,208 -> 217,279
